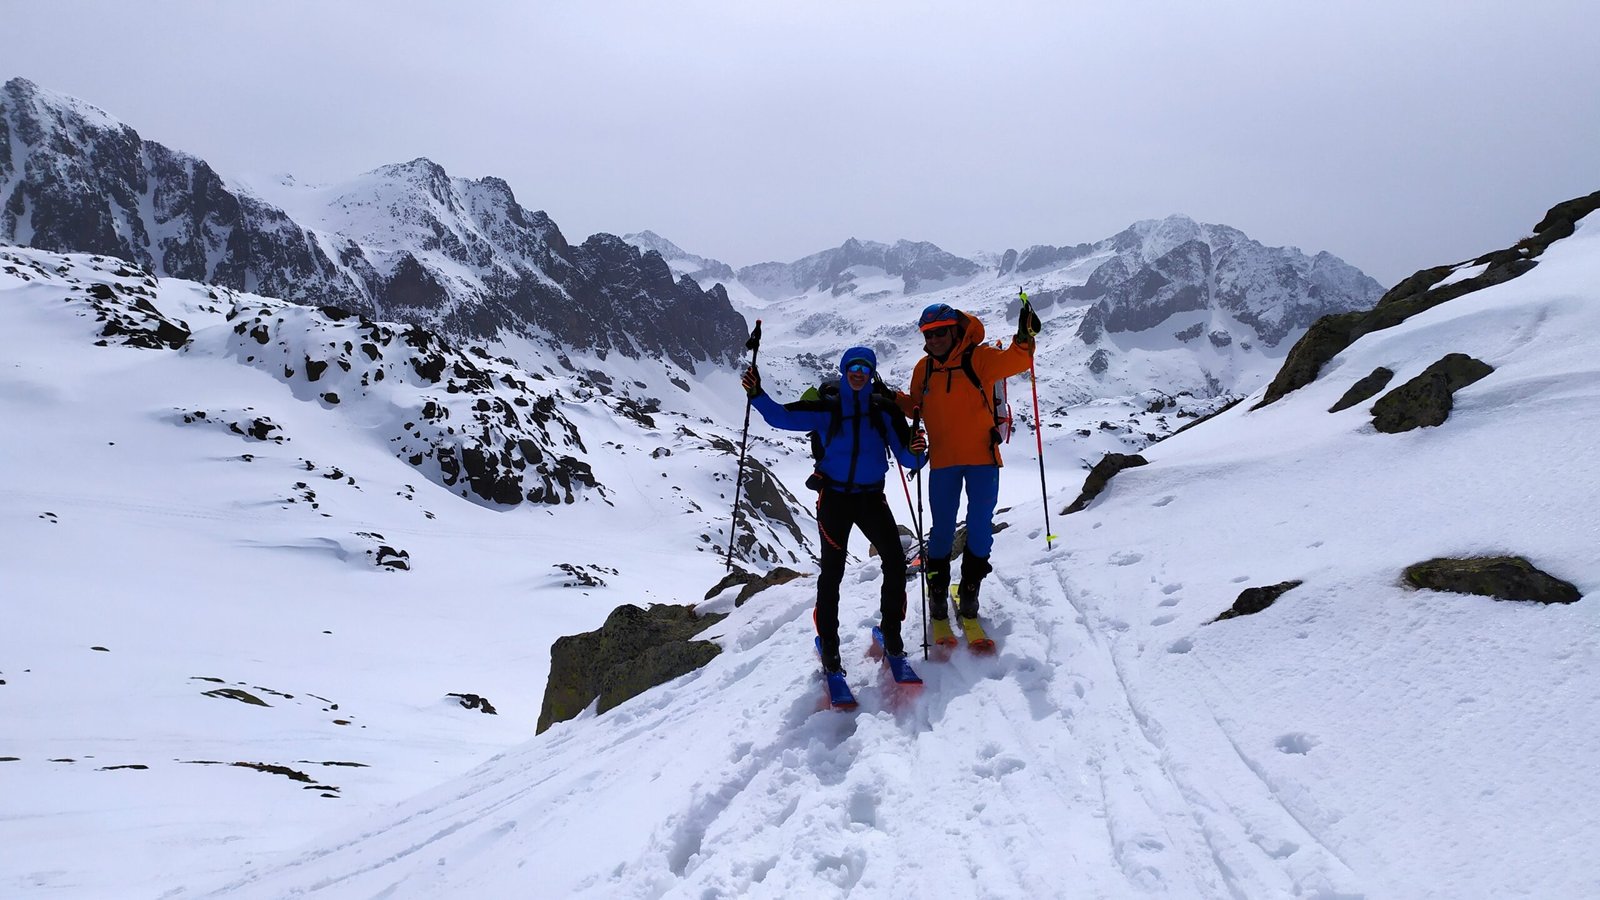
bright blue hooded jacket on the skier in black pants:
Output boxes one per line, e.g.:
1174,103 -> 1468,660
750,348 -> 928,492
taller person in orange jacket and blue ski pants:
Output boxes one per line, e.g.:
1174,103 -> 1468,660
896,303 -> 1040,618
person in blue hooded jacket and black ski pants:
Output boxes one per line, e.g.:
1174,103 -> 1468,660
741,348 -> 928,673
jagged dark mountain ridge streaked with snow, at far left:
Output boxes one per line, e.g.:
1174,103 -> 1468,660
0,78 -> 746,370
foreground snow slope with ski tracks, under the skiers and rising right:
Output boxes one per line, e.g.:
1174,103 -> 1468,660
124,209 -> 1600,897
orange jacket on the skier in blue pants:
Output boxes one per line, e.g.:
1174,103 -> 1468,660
894,312 -> 1034,469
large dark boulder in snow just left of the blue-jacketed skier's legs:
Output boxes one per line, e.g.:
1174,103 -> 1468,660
538,604 -> 725,732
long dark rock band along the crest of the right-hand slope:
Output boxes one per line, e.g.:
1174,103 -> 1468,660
1253,191 -> 1600,410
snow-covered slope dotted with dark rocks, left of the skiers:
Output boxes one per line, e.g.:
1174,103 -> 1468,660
0,247 -> 810,897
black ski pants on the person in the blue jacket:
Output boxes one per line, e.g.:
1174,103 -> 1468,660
816,490 -> 906,668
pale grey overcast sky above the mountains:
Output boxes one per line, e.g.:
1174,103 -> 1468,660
0,0 -> 1600,283
